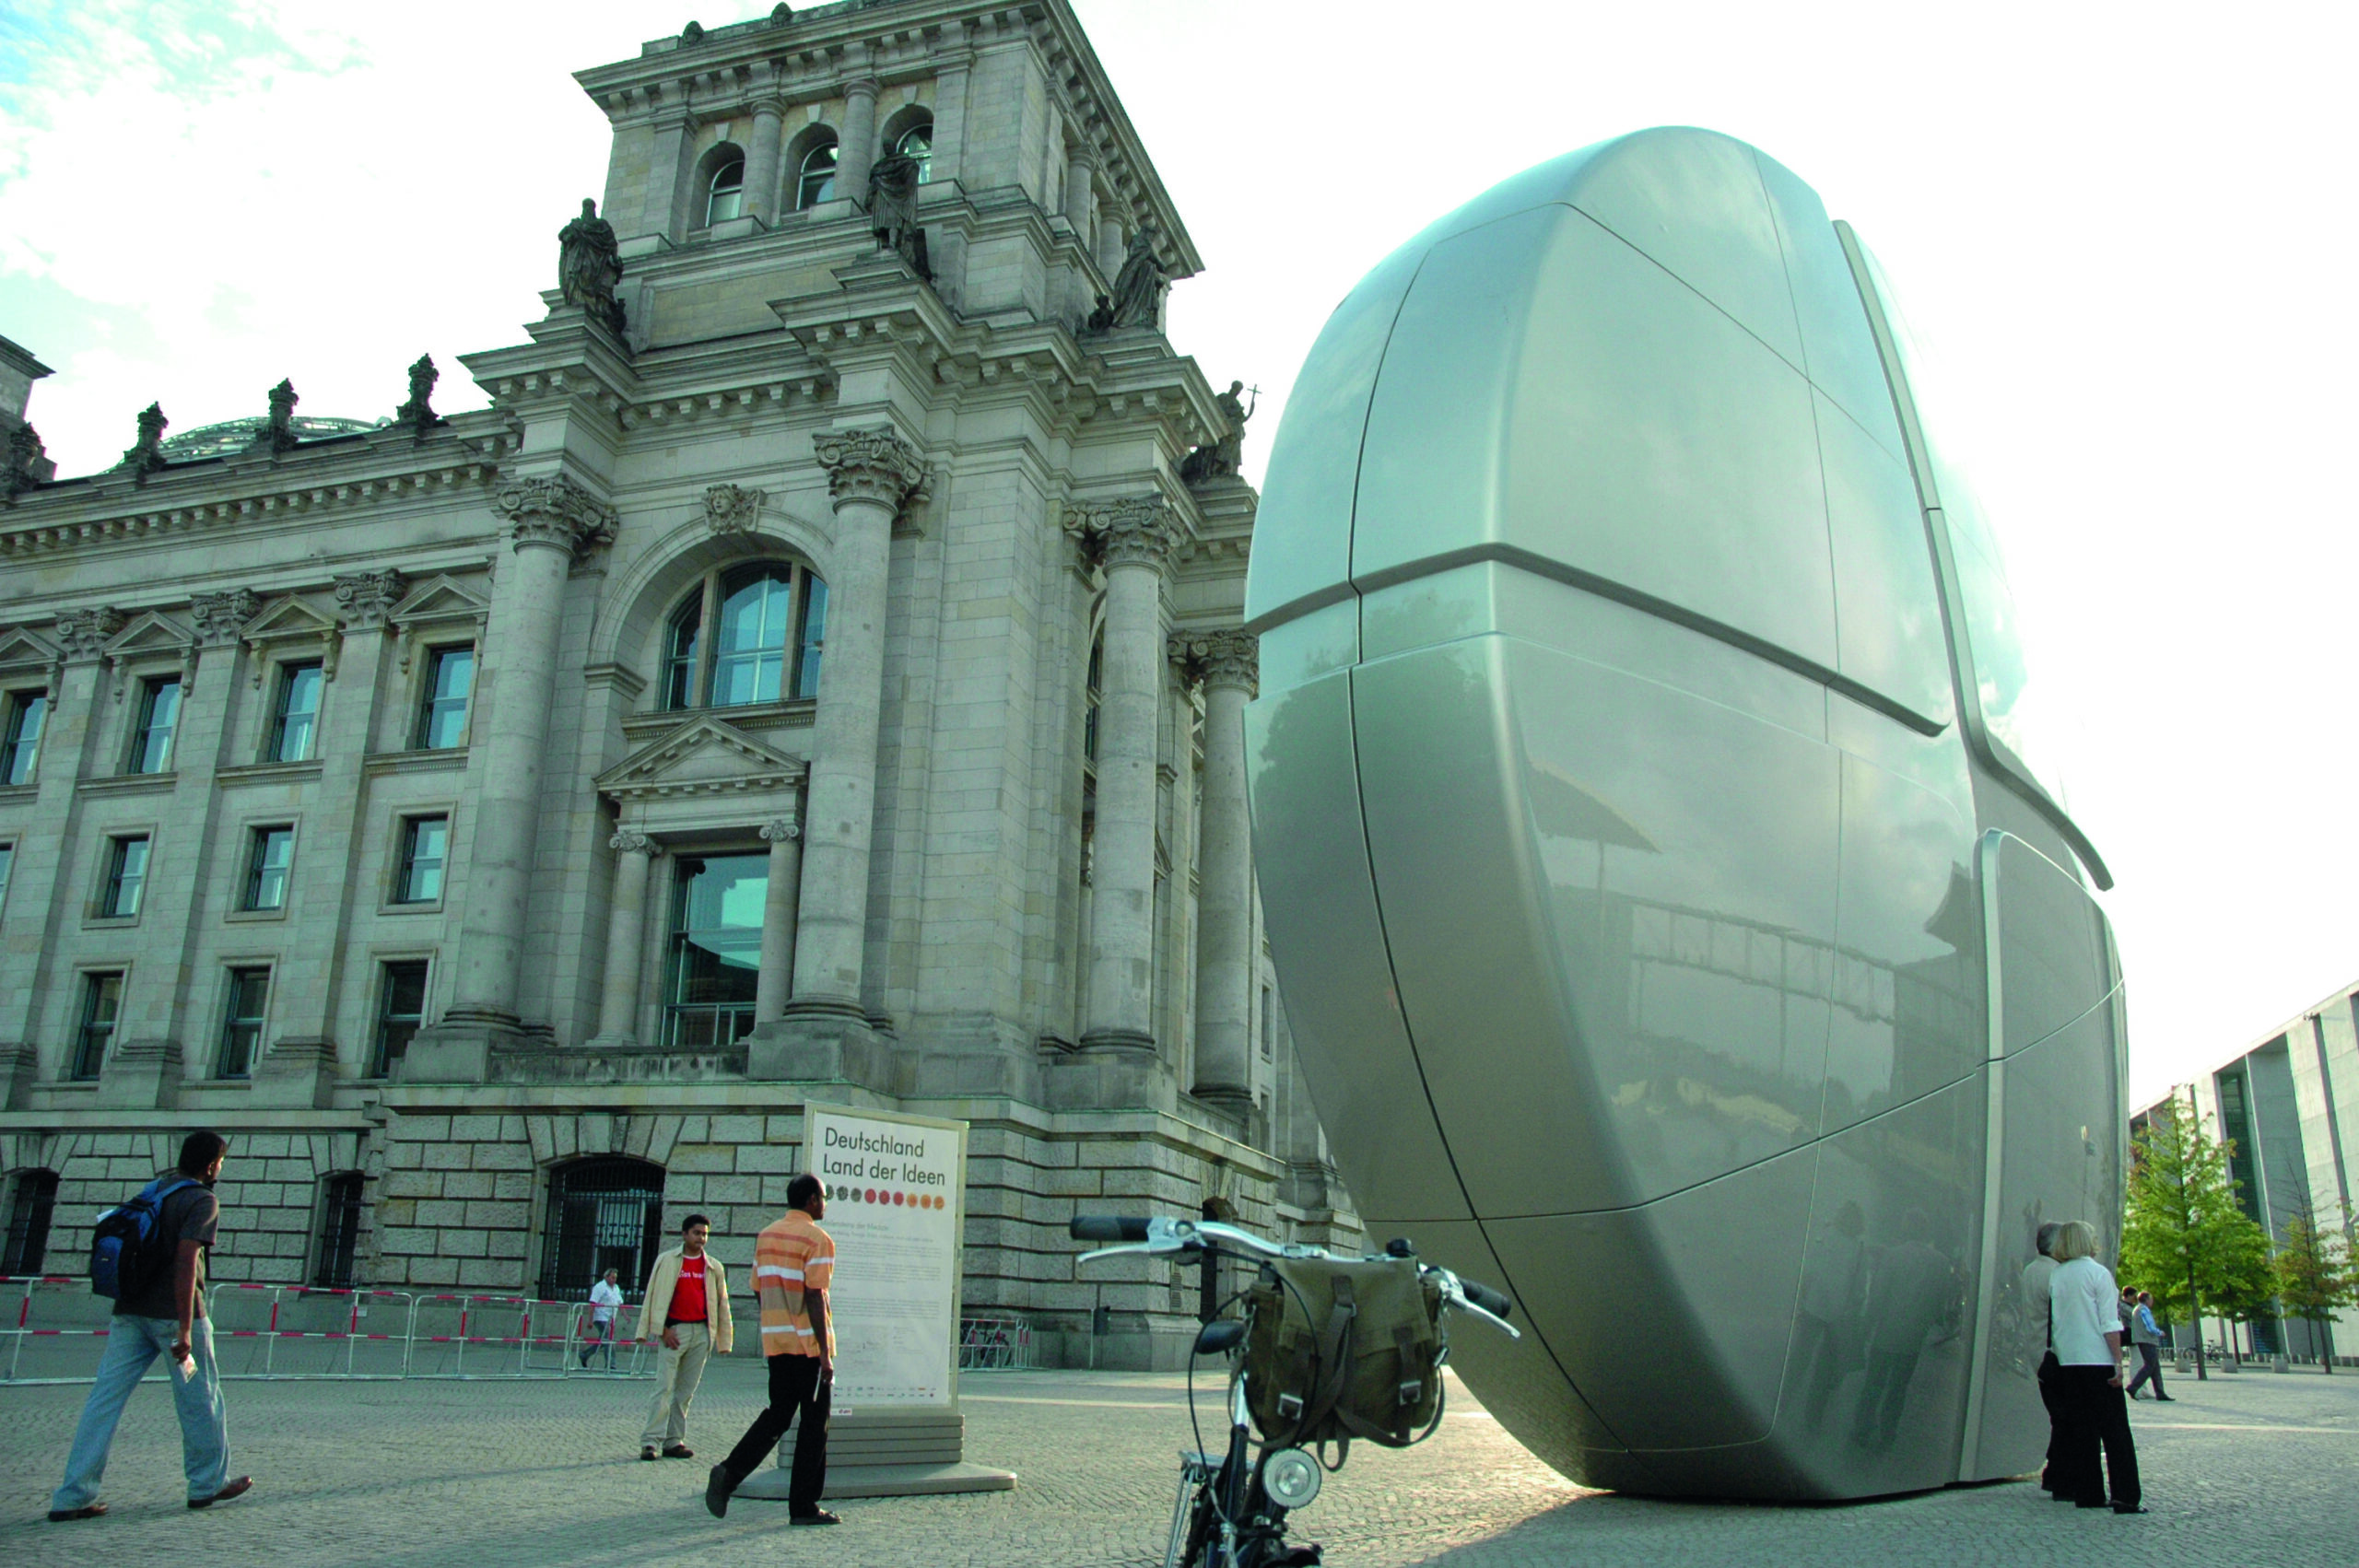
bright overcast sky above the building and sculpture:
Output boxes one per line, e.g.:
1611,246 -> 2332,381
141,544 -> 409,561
0,0 -> 2359,1099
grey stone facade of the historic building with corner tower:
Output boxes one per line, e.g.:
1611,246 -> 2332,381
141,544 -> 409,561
0,0 -> 1356,1365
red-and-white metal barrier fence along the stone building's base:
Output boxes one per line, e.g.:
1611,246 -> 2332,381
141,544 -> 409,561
0,1276 -> 651,1382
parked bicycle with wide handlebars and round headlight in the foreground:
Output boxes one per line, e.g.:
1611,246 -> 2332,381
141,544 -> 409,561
1069,1214 -> 1521,1568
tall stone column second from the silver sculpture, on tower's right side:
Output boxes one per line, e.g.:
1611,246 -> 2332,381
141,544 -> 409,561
1078,495 -> 1180,1051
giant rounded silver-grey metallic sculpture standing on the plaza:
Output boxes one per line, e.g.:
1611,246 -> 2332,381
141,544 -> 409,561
1246,130 -> 2123,1497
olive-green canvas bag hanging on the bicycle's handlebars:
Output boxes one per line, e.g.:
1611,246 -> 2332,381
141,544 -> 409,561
1246,1257 -> 1444,1464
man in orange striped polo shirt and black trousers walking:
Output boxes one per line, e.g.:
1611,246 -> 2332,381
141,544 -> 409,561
705,1172 -> 842,1526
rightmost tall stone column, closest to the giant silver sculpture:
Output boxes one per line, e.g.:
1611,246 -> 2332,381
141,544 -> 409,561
1172,632 -> 1260,1110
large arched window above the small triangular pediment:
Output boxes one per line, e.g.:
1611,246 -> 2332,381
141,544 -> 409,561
663,561 -> 828,709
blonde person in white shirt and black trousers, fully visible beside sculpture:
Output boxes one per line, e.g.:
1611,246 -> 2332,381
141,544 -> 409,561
2048,1219 -> 2147,1514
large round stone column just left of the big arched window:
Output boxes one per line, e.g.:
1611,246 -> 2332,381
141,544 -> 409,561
439,474 -> 616,1033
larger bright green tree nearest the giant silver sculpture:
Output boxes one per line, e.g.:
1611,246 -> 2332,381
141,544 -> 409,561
2120,1087 -> 2271,1379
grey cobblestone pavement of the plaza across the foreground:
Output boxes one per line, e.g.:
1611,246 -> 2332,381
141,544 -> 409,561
0,1361 -> 2359,1568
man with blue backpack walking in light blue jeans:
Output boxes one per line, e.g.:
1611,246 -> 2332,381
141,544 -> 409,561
50,1132 -> 254,1521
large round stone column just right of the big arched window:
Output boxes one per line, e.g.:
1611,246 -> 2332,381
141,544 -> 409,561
778,427 -> 922,1019
